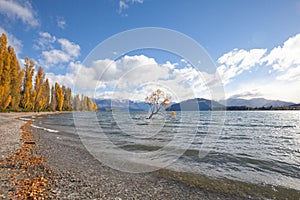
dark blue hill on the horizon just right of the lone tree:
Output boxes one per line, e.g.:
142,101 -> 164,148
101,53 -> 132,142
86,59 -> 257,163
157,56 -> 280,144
168,98 -> 224,111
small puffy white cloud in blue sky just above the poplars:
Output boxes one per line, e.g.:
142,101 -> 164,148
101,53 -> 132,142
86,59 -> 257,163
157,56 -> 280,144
34,32 -> 80,68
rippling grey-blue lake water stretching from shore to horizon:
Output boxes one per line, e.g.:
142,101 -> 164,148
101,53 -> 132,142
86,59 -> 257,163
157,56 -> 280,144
31,111 -> 300,190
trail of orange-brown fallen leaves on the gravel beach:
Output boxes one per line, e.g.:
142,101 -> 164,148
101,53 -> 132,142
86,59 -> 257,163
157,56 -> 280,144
0,122 -> 56,199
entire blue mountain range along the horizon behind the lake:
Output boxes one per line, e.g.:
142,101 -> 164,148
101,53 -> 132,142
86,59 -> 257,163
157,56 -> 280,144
95,98 -> 298,111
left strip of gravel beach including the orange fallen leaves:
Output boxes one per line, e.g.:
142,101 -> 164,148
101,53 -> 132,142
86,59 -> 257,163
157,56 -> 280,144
0,112 -> 69,199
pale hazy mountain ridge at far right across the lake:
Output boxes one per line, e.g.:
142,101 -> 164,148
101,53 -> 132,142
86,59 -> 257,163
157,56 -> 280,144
220,98 -> 294,108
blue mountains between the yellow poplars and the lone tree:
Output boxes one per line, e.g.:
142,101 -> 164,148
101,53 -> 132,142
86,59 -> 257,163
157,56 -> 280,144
94,99 -> 149,111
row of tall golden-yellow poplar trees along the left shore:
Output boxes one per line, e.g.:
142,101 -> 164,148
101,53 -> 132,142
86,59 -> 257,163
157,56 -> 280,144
0,34 -> 98,111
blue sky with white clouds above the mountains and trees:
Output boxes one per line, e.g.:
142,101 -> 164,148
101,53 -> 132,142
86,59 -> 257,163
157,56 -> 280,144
0,0 -> 300,103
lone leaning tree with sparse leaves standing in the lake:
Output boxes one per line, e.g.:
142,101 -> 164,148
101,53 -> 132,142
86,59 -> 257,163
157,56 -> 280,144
145,89 -> 172,119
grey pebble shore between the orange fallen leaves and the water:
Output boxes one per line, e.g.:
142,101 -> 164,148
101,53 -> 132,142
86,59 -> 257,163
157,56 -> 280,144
0,112 -> 300,199
